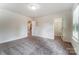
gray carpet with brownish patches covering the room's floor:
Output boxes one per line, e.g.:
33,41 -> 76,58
0,36 -> 68,55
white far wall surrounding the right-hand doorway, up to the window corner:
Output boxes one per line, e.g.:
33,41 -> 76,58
34,10 -> 72,42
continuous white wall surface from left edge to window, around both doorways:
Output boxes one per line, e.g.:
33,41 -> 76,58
0,9 -> 71,43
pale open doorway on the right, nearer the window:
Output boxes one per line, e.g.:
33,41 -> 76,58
54,18 -> 63,37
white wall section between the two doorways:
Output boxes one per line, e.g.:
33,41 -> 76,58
33,16 -> 54,39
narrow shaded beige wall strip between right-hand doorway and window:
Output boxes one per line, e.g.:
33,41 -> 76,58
63,10 -> 72,42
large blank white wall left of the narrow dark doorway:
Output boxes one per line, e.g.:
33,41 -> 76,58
0,9 -> 27,43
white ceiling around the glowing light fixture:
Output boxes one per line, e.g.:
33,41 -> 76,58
0,3 -> 73,17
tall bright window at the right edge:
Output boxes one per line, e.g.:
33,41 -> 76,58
73,5 -> 79,42
